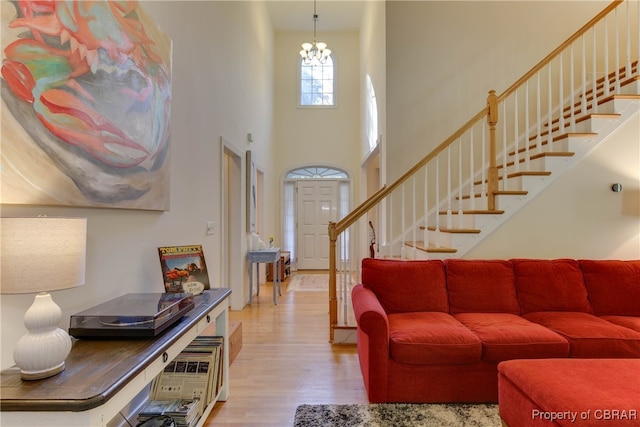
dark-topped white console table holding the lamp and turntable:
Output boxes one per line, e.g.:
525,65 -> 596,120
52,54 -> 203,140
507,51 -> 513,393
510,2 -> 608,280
0,288 -> 231,427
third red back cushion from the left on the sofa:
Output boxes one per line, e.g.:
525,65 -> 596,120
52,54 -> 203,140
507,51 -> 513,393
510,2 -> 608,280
511,259 -> 591,313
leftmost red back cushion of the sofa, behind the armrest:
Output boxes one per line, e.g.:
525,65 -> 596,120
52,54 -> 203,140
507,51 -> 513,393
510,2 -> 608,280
362,258 -> 449,314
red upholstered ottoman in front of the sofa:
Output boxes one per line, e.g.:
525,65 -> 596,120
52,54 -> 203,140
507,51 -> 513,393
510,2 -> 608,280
498,359 -> 640,427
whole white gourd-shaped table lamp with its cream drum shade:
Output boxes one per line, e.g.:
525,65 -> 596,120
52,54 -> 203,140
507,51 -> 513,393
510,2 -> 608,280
0,217 -> 87,380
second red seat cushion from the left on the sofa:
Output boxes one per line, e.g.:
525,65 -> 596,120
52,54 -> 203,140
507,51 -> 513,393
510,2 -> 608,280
454,313 -> 569,363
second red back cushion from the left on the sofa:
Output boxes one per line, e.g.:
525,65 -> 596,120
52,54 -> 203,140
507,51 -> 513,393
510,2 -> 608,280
444,259 -> 520,314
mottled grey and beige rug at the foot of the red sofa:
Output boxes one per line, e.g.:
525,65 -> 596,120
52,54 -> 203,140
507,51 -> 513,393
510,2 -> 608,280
294,403 -> 501,427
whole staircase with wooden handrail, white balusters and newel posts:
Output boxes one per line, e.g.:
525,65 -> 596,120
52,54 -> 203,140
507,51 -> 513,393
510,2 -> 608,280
329,0 -> 640,342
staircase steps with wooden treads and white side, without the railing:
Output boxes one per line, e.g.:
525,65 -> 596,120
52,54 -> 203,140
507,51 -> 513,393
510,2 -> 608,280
408,69 -> 640,259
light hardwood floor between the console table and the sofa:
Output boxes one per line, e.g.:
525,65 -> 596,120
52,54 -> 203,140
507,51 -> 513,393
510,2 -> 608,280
204,273 -> 367,427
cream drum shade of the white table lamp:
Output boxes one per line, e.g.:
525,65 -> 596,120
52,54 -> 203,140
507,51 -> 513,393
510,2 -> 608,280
0,217 -> 87,294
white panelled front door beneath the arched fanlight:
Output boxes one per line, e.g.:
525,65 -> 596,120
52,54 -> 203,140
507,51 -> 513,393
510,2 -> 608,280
298,179 -> 338,270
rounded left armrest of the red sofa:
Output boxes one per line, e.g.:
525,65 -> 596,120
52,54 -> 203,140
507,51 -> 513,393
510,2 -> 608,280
351,284 -> 390,403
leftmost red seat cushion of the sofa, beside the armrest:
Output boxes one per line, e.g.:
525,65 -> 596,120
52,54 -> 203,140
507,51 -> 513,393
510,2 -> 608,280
388,311 -> 482,365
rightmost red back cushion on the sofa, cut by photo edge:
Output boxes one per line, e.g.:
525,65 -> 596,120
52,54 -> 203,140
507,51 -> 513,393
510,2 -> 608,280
580,260 -> 640,316
